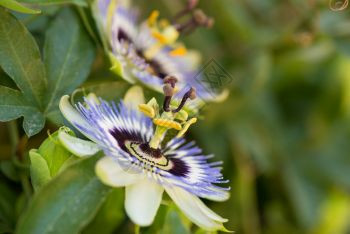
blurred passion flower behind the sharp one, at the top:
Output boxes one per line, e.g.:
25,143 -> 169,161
93,0 -> 227,111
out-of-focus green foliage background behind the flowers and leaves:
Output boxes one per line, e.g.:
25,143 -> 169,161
0,0 -> 350,234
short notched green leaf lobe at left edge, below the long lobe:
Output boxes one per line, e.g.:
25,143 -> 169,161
0,86 -> 45,136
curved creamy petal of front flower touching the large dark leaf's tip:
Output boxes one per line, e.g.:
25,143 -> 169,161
95,156 -> 144,187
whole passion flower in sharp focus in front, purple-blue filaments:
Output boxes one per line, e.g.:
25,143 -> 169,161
58,85 -> 229,231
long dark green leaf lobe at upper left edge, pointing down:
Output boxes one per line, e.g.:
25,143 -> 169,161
0,8 -> 47,109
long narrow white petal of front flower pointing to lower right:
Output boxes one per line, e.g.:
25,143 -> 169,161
165,186 -> 227,231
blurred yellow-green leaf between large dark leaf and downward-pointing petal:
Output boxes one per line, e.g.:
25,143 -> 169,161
82,188 -> 124,234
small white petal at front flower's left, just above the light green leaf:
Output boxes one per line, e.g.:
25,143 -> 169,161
58,128 -> 100,157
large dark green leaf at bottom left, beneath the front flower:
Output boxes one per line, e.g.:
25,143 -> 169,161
16,155 -> 110,234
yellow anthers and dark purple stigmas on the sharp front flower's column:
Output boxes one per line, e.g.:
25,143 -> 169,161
139,76 -> 197,149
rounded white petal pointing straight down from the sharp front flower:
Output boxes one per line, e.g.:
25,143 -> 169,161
125,178 -> 164,226
